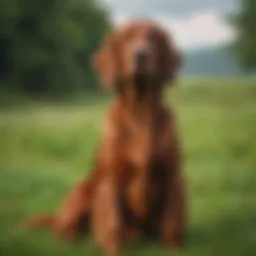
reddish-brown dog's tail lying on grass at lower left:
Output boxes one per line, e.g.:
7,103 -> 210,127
20,215 -> 56,229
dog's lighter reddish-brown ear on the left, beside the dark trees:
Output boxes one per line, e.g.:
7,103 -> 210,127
92,33 -> 118,88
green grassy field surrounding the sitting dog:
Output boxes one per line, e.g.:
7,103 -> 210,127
0,80 -> 256,256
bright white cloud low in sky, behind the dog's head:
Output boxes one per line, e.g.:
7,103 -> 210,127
114,11 -> 236,49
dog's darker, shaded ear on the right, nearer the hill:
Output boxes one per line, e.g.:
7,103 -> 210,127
159,29 -> 182,83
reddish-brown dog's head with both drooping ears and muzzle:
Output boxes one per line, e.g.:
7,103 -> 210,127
93,21 -> 181,90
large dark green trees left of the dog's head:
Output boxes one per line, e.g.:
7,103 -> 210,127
0,0 -> 111,96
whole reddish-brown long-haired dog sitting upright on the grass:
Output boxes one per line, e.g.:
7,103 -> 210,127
22,20 -> 187,255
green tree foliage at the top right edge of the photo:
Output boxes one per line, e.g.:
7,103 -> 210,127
233,0 -> 256,71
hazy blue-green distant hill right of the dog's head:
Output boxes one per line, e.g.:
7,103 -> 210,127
182,47 -> 242,76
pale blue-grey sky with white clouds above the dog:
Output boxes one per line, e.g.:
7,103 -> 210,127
101,0 -> 240,50
